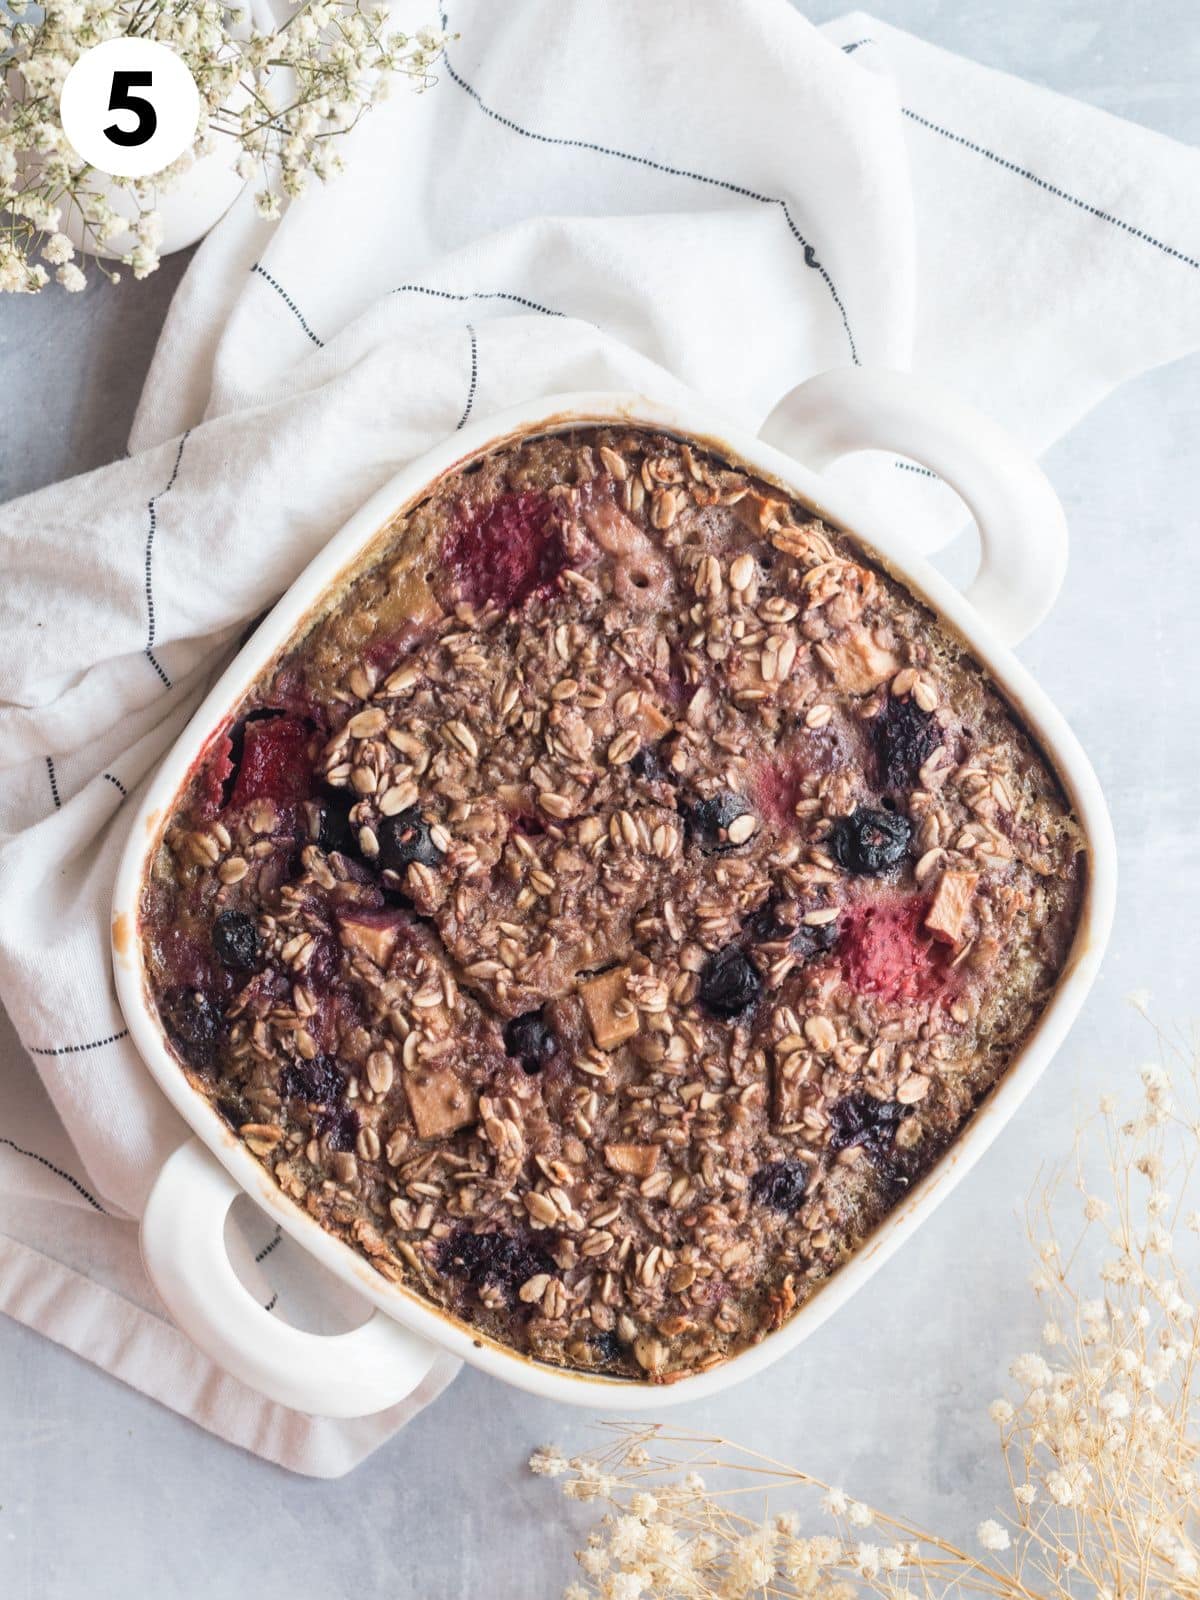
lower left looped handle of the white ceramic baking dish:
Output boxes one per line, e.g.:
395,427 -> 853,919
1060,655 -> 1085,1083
141,1139 -> 440,1416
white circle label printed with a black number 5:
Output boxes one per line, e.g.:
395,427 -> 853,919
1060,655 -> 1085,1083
59,38 -> 200,178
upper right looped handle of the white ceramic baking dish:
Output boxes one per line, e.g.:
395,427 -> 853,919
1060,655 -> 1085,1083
760,366 -> 1067,645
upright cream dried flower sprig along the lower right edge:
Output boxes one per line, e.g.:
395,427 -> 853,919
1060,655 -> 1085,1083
979,1043 -> 1200,1595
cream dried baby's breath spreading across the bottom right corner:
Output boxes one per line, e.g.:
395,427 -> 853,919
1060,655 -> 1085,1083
538,1011 -> 1200,1600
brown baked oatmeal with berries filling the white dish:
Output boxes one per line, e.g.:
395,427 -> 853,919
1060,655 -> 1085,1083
141,426 -> 1086,1381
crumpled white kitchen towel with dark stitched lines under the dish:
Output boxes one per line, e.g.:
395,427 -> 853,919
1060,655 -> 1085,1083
0,0 -> 1200,1474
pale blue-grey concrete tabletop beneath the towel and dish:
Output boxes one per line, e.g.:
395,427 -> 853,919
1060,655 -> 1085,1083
0,9 -> 1200,1600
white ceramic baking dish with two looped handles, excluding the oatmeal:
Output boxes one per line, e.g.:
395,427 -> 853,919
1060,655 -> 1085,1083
112,370 -> 1115,1416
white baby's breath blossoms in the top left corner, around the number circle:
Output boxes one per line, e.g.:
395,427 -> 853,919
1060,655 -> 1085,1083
0,0 -> 445,293
